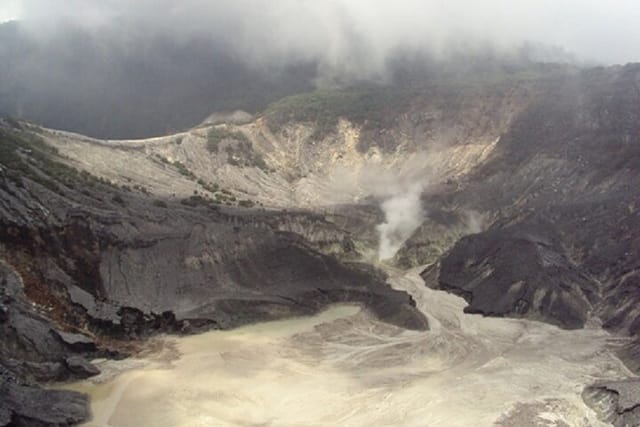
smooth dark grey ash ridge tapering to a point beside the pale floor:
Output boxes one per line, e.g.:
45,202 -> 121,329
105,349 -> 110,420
101,224 -> 426,328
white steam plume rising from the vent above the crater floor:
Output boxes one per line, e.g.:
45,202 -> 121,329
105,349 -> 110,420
376,184 -> 424,261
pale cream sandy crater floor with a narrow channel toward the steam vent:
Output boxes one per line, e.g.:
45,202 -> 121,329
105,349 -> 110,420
61,269 -> 629,427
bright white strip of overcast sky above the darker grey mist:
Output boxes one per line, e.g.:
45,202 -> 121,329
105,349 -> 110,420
0,0 -> 640,66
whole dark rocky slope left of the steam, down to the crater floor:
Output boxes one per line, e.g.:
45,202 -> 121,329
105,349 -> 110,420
0,122 -> 428,425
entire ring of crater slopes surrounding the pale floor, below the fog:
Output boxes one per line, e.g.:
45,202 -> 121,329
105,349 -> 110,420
0,61 -> 640,425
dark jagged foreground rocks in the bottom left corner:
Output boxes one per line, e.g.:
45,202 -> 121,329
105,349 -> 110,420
0,262 -> 93,426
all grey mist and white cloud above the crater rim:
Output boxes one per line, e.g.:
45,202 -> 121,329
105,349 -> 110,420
0,0 -> 640,138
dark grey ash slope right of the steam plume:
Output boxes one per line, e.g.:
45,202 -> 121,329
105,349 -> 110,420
416,65 -> 640,425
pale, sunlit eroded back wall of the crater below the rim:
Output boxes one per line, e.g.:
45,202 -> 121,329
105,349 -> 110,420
37,80 -> 539,210
